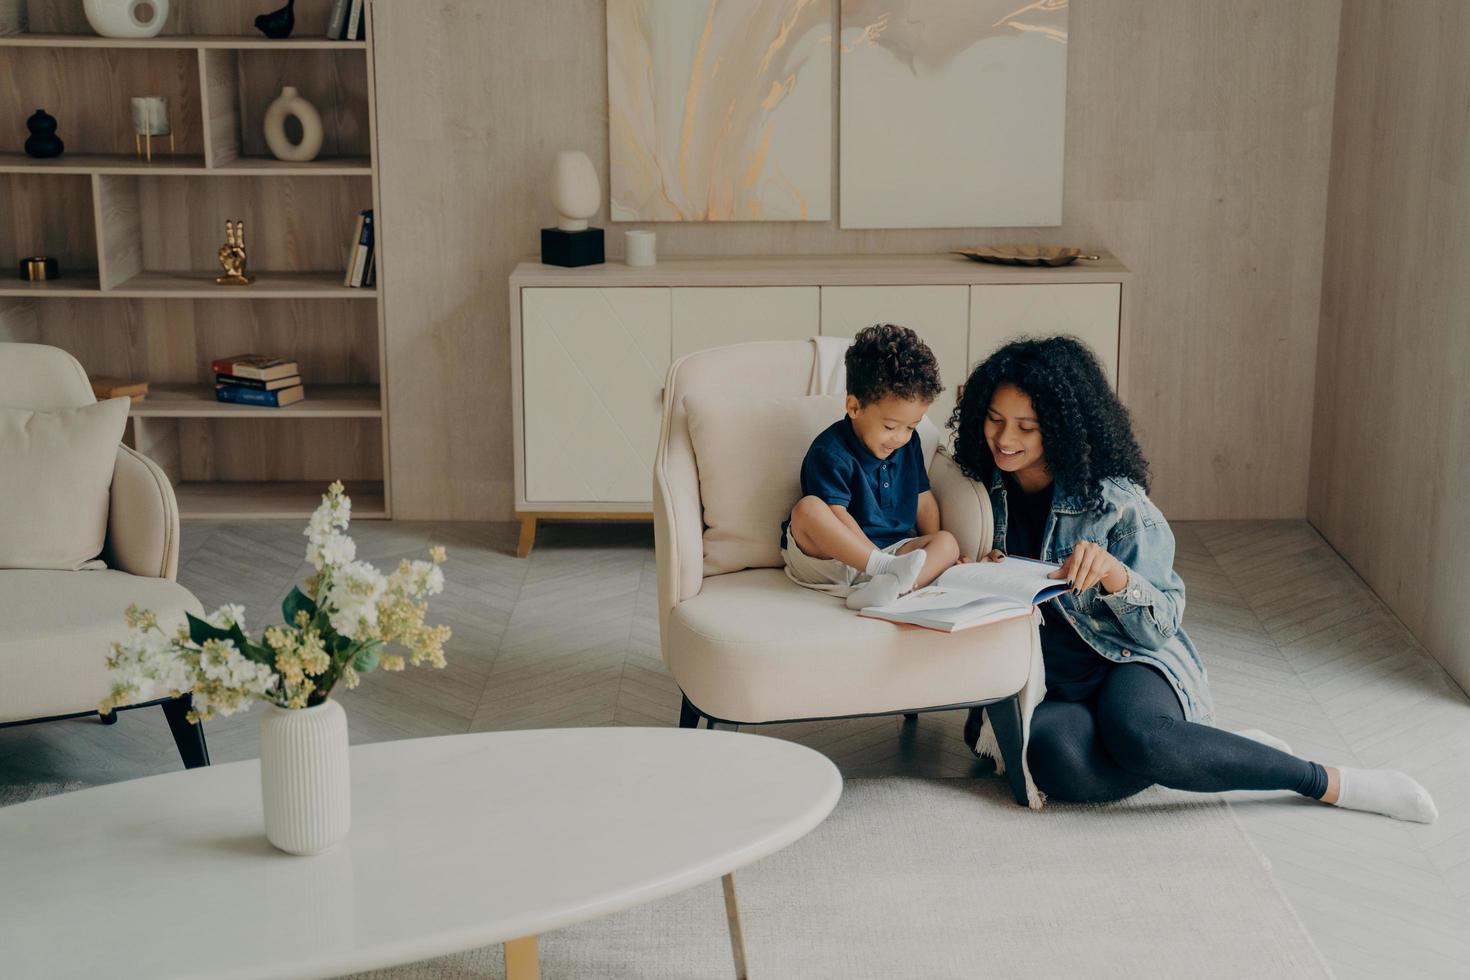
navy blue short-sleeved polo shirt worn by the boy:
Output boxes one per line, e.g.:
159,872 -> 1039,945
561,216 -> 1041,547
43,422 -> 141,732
781,416 -> 929,548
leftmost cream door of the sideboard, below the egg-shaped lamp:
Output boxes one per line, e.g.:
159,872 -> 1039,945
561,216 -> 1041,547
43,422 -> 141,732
520,288 -> 670,502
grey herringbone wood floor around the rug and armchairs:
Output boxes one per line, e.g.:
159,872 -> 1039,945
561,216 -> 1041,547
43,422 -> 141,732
0,522 -> 1470,977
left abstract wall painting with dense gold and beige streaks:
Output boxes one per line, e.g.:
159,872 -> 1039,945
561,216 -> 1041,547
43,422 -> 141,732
607,0 -> 833,222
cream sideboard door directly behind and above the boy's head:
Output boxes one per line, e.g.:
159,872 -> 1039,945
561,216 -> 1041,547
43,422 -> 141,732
822,287 -> 970,430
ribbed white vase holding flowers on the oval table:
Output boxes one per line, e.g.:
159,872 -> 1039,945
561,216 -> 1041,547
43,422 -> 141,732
260,698 -> 351,854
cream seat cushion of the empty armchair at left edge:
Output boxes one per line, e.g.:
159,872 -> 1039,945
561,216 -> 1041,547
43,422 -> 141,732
0,569 -> 204,723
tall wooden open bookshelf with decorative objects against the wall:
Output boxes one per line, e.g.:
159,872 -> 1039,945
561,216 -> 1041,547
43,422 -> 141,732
0,0 -> 391,519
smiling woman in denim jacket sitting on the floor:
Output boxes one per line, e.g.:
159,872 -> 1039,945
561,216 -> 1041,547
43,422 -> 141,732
950,336 -> 1438,823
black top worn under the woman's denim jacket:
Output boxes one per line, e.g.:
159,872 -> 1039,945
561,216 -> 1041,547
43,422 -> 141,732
1001,473 -> 1113,701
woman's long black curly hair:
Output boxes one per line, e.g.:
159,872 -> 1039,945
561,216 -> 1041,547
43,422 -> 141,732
950,336 -> 1148,511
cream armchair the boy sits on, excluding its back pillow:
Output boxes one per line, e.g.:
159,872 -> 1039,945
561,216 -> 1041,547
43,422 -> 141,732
653,341 -> 1041,805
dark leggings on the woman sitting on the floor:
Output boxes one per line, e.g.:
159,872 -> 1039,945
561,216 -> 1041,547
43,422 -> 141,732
1026,663 -> 1327,802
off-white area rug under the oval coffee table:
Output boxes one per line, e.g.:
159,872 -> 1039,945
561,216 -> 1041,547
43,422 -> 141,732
346,779 -> 1332,980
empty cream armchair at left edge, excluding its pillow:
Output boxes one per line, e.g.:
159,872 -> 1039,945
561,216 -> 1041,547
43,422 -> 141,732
0,344 -> 209,768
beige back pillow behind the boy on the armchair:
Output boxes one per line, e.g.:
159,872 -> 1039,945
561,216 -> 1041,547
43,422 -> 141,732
684,394 -> 844,576
